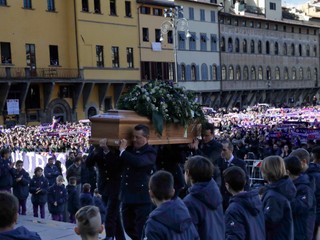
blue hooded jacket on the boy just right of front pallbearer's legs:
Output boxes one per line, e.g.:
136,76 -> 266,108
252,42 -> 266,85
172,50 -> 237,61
142,198 -> 200,240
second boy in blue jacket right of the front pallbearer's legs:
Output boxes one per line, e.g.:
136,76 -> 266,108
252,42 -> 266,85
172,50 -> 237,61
183,155 -> 225,240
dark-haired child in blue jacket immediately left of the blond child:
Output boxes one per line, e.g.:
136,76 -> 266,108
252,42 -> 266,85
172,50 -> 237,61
223,166 -> 266,240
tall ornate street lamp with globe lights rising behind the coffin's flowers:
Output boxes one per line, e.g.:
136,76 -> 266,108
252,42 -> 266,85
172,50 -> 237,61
160,6 -> 191,83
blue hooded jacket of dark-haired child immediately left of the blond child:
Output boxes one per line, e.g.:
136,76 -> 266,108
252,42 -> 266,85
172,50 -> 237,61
225,191 -> 266,240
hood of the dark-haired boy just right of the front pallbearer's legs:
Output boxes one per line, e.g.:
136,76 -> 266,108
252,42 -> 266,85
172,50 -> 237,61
150,198 -> 192,233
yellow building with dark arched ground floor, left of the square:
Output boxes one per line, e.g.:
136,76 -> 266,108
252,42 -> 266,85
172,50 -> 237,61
0,0 -> 140,125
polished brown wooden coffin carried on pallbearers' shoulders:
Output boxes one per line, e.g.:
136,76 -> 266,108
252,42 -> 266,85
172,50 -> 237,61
90,110 -> 201,146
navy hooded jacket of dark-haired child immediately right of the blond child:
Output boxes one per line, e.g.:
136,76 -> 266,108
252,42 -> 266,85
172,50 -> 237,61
291,174 -> 316,240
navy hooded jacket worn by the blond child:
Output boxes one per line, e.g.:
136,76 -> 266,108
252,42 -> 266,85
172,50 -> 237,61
262,176 -> 297,240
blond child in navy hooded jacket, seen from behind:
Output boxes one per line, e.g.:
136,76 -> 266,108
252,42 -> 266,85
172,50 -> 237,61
261,156 -> 297,240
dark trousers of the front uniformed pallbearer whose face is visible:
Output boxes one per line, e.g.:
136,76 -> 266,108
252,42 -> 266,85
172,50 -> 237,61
121,203 -> 152,240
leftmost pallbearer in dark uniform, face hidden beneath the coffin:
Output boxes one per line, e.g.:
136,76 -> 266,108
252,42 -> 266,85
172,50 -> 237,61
86,139 -> 125,240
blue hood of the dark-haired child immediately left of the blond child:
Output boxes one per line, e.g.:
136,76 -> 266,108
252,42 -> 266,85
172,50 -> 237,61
230,190 -> 262,216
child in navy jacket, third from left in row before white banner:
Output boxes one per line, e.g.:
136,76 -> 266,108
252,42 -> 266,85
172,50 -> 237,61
29,167 -> 49,218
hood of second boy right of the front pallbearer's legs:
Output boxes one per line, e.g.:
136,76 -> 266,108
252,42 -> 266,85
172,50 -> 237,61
189,179 -> 222,209
